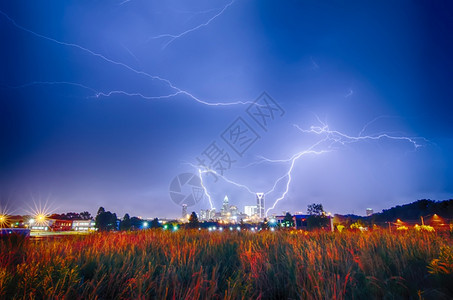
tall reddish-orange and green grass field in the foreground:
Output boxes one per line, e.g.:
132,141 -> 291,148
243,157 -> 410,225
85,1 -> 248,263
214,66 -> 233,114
0,230 -> 453,299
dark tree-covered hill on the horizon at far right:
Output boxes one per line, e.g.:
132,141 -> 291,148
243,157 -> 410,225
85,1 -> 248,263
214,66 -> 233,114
335,199 -> 453,223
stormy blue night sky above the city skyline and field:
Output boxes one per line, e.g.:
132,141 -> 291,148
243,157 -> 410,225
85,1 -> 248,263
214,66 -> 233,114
0,0 -> 453,217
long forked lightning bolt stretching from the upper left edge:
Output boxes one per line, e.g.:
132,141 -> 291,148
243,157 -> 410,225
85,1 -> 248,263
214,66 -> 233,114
0,9 -> 252,106
